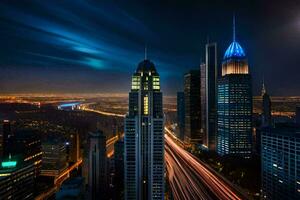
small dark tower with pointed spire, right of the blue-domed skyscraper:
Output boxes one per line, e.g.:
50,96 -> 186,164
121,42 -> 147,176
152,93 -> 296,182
261,82 -> 272,127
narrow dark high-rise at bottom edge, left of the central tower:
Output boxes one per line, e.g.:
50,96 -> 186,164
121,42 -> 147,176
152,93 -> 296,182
88,130 -> 107,200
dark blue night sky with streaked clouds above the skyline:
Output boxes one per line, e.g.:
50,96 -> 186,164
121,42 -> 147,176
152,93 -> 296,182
0,0 -> 300,96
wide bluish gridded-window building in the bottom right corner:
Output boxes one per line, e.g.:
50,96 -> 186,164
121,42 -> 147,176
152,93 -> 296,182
261,127 -> 300,199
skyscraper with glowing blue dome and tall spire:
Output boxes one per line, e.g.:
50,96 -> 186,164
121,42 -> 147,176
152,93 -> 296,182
217,16 -> 252,157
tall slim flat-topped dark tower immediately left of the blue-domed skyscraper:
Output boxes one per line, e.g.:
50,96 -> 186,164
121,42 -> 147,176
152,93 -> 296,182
200,43 -> 218,150
